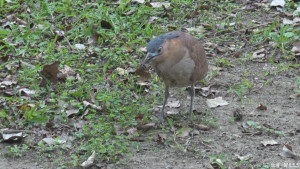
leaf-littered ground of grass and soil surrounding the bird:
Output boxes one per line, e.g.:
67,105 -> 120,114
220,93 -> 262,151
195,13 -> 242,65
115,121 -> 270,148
0,0 -> 300,169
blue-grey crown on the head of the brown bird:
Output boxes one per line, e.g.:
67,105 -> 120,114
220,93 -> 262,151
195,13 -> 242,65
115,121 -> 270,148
147,32 -> 179,52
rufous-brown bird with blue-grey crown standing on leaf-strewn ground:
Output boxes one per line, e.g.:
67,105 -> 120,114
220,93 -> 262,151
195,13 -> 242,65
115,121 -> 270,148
142,31 -> 208,122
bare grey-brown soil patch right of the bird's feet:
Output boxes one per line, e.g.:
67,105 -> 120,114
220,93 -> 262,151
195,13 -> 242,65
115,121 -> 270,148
126,61 -> 300,169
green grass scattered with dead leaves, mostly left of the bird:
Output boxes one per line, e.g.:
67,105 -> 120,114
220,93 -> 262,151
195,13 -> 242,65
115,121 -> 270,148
0,0 -> 300,167
